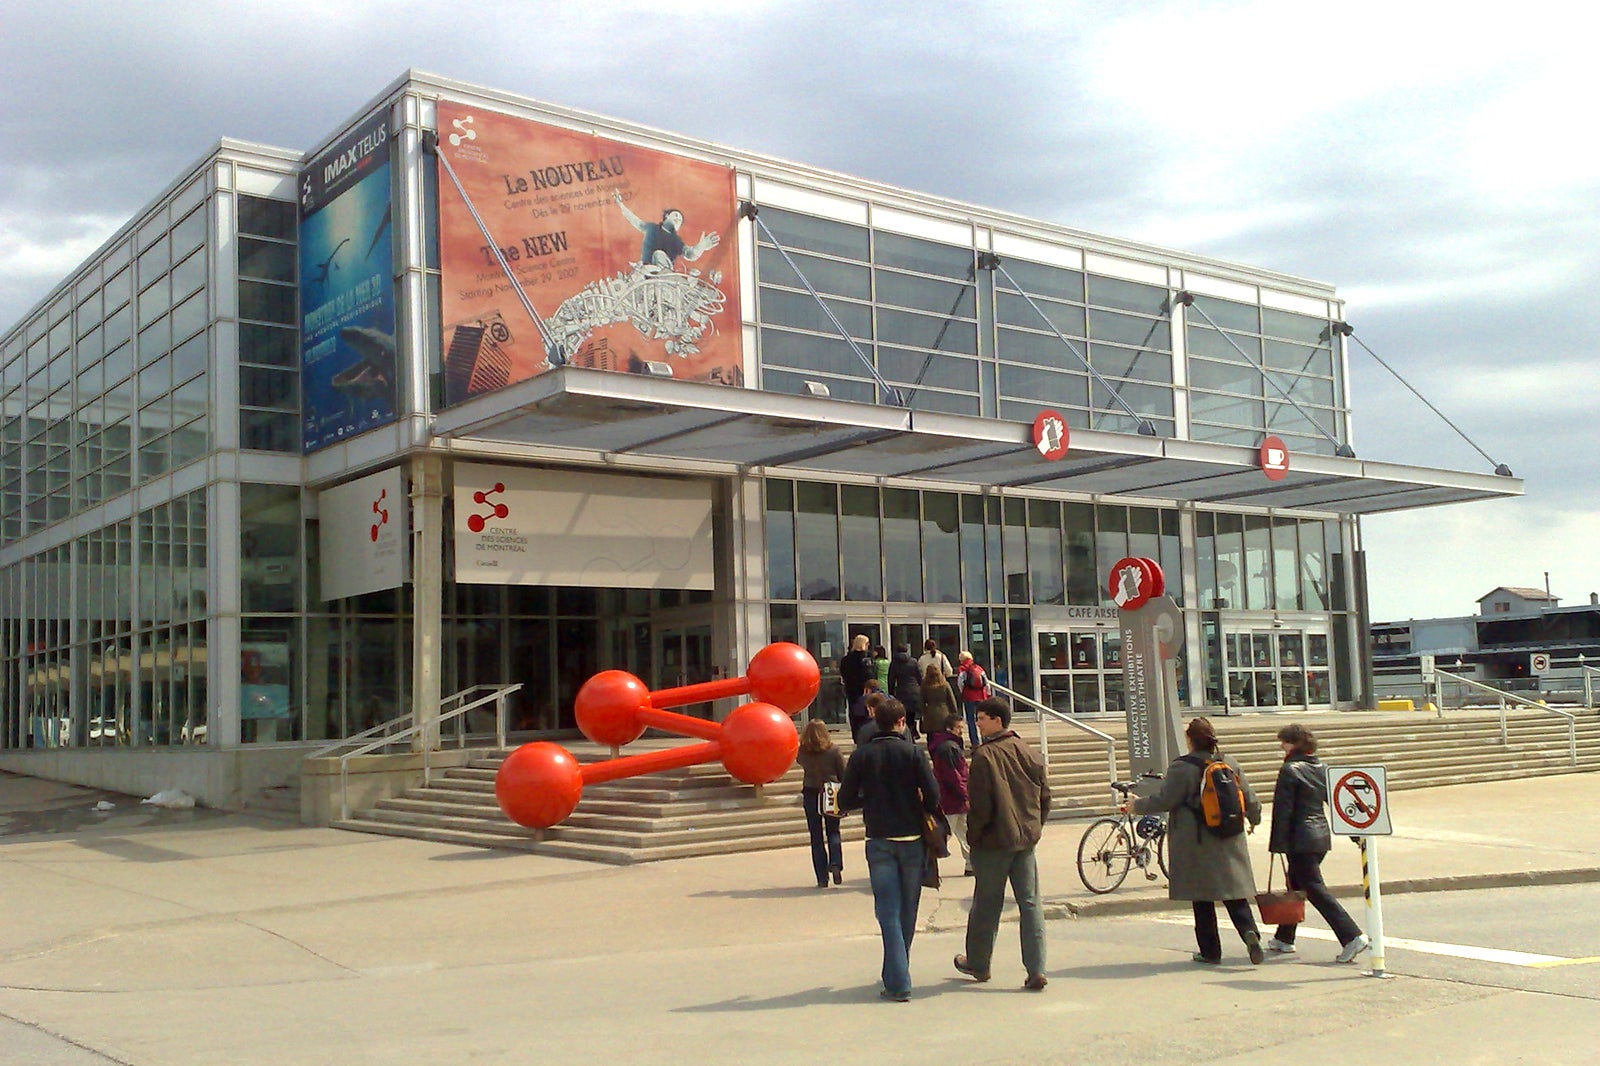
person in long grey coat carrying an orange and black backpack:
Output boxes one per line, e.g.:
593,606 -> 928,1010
1123,719 -> 1266,965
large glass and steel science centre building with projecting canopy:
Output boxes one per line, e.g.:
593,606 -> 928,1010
0,72 -> 1522,805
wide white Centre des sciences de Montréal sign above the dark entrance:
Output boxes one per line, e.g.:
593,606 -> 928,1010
454,464 -> 714,589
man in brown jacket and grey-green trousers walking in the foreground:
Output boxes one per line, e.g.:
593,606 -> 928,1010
955,698 -> 1050,992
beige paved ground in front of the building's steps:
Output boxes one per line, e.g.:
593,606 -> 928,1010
9,773 -> 1600,1066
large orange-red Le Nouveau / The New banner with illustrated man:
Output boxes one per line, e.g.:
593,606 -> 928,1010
438,102 -> 744,403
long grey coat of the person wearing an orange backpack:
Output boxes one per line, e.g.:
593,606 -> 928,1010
1133,745 -> 1261,903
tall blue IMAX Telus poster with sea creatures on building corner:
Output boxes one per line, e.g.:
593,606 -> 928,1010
299,114 -> 398,453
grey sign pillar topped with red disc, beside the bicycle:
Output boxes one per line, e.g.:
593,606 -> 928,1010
1106,559 -> 1184,781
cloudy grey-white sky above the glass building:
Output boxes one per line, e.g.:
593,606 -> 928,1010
0,0 -> 1600,619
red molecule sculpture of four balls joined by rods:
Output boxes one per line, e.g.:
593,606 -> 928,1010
494,643 -> 822,829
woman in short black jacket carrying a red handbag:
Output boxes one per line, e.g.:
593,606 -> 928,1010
1267,723 -> 1368,962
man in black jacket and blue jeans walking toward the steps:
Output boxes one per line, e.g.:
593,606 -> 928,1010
838,699 -> 939,1004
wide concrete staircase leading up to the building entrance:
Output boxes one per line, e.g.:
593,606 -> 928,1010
334,711 -> 1600,864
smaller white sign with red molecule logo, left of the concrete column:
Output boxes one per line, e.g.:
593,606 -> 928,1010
318,467 -> 411,600
